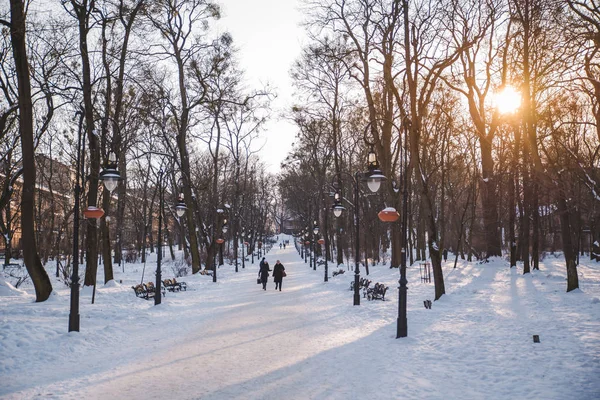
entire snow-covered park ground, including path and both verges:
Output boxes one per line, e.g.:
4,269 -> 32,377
0,236 -> 600,400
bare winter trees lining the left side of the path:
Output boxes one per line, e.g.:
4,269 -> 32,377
0,0 -> 277,301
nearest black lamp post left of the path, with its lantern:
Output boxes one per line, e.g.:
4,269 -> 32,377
69,111 -> 121,332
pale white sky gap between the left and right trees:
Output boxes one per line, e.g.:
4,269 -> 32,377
218,0 -> 305,173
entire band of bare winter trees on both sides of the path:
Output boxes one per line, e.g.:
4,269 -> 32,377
0,0 -> 600,301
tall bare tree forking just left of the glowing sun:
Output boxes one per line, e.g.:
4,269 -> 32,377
445,0 -> 508,257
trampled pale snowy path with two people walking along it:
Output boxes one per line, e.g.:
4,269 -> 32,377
67,247 -> 366,399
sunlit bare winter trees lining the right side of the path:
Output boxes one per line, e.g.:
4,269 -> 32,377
280,0 -> 600,299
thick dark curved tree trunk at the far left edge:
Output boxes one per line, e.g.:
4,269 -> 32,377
10,0 -> 52,302
